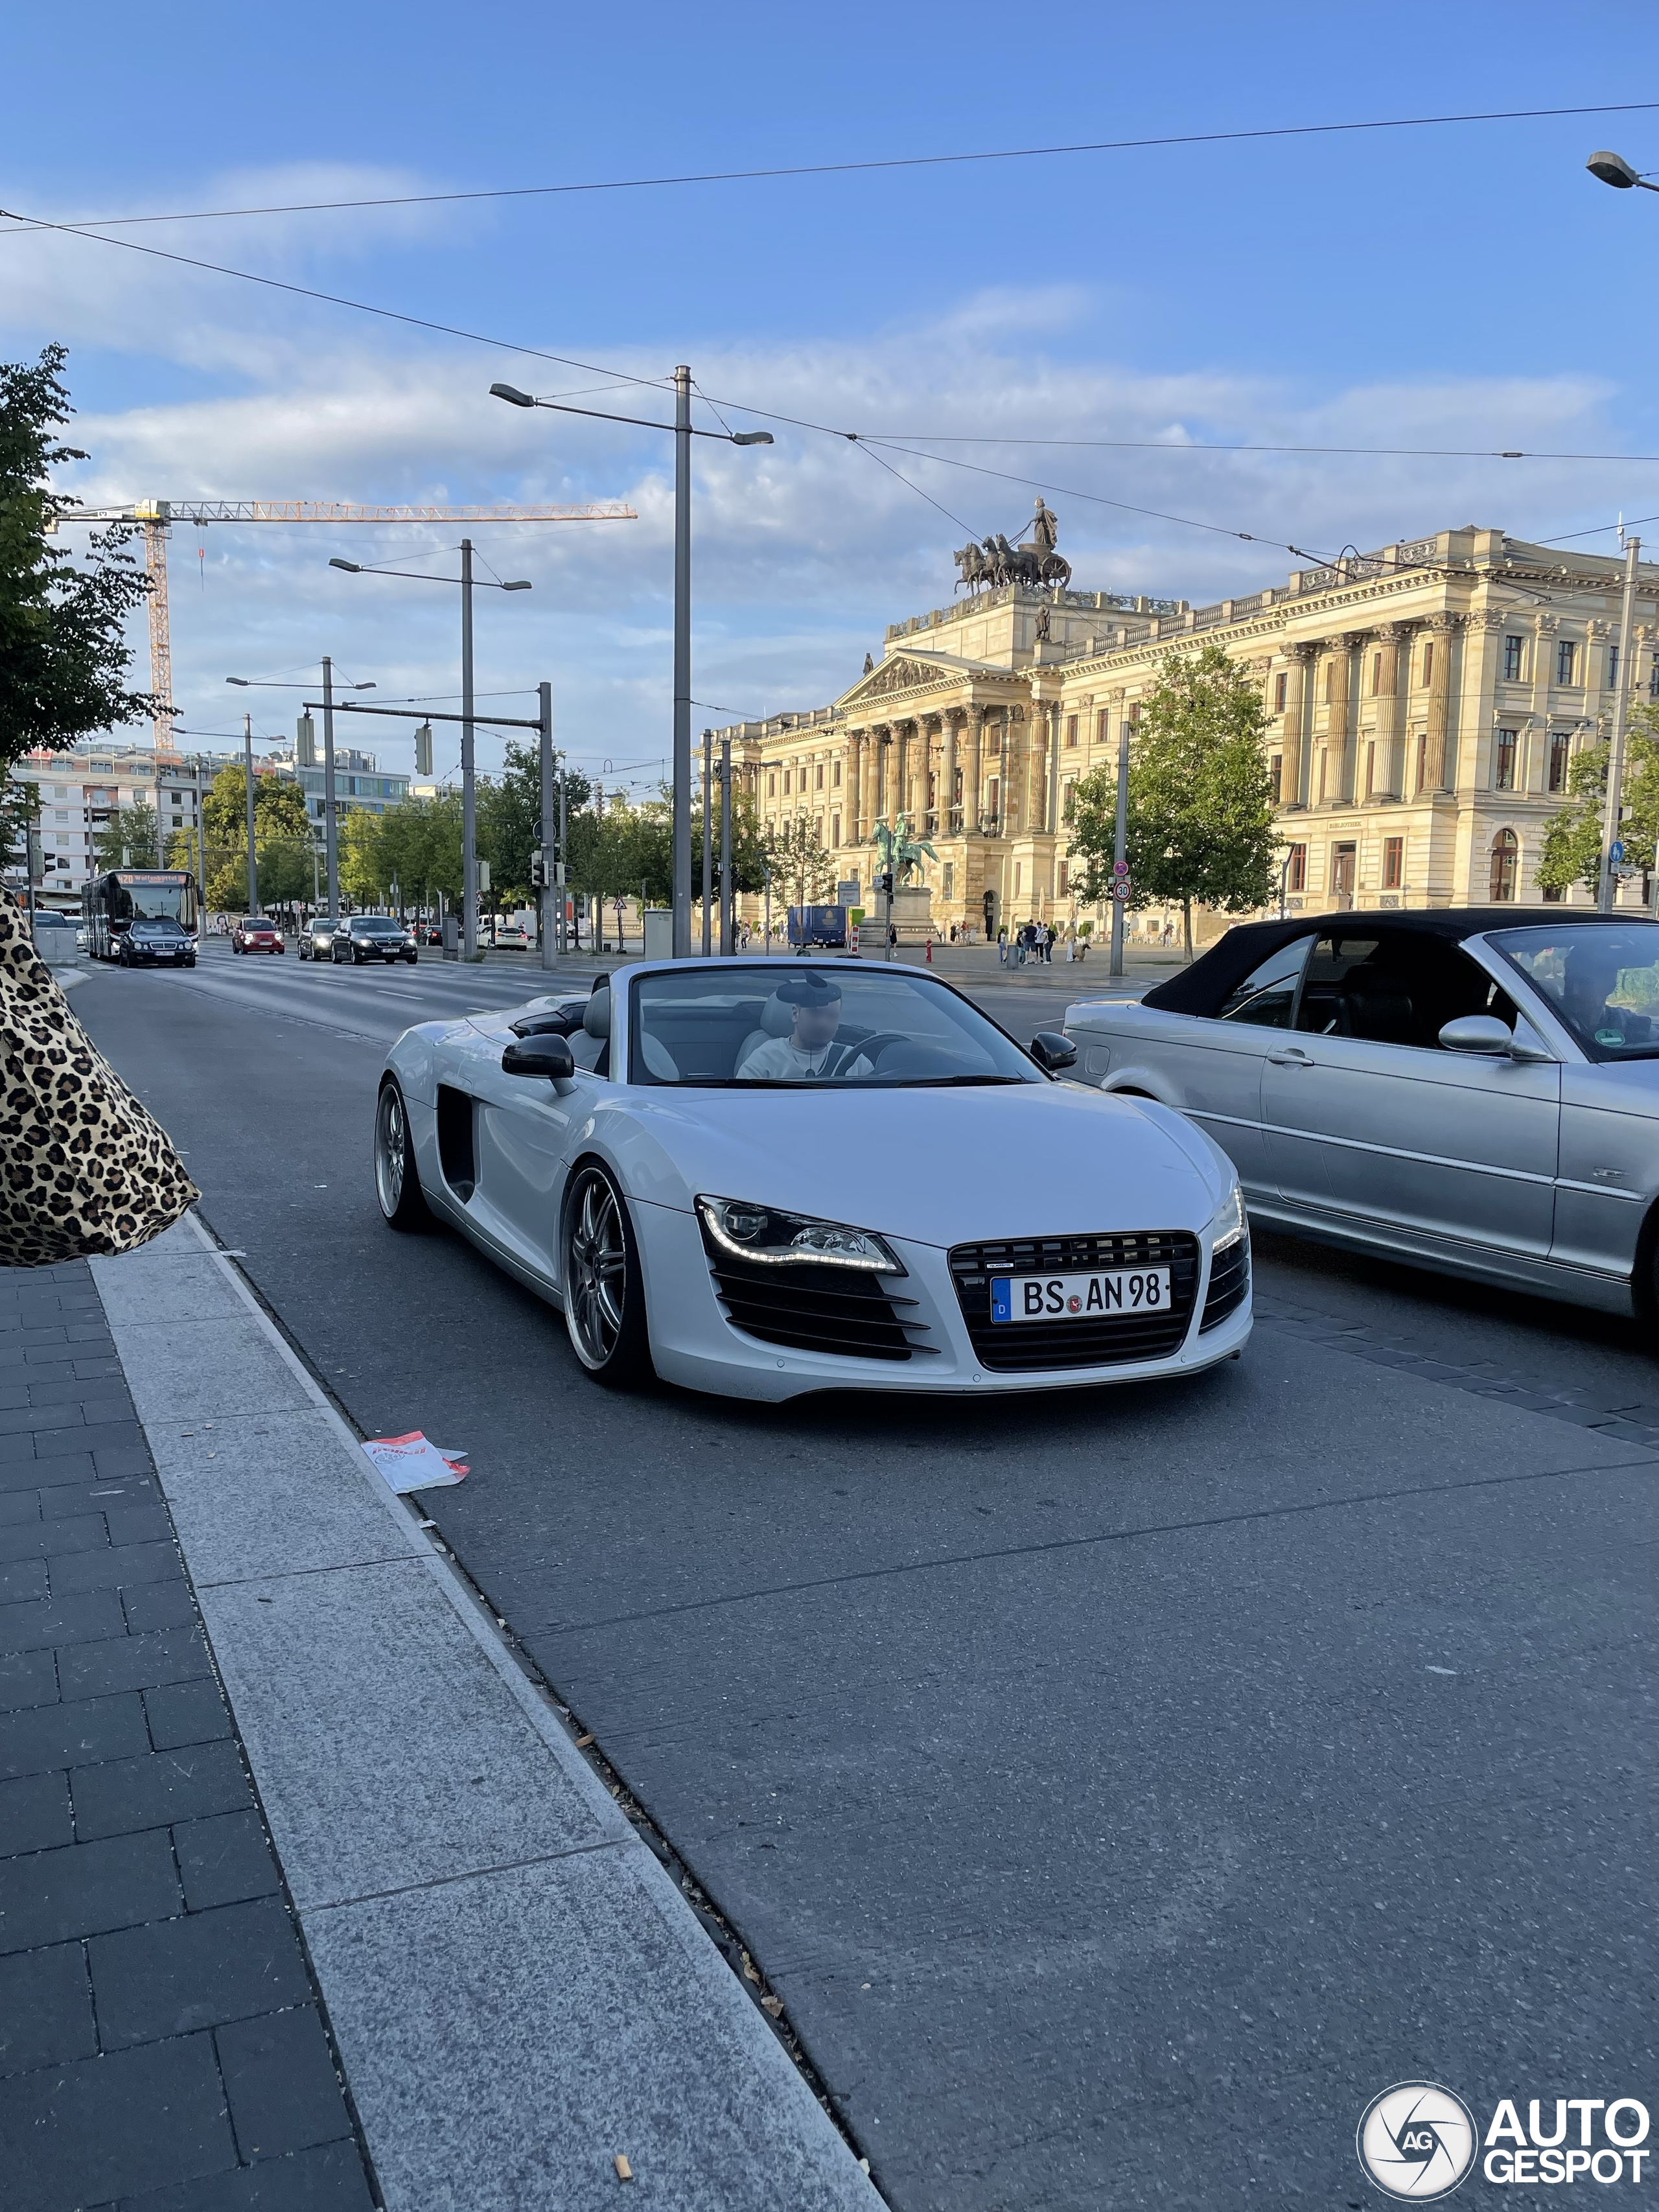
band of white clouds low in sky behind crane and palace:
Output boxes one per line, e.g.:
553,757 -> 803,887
0,220 -> 1659,761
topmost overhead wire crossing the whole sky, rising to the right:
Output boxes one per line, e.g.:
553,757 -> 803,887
0,100 -> 1659,237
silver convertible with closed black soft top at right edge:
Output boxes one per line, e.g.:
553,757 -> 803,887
1066,907 -> 1659,1314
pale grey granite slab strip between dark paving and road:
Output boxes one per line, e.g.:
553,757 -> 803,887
83,1219 -> 881,2212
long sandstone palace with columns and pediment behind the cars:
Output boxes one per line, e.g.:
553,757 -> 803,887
717,526 -> 1659,933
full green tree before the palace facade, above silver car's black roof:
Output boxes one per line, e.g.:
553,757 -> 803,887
1071,646 -> 1276,960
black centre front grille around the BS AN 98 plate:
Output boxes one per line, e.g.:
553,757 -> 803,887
951,1230 -> 1199,1373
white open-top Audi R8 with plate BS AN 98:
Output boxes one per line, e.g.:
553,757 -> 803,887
374,960 -> 1250,1400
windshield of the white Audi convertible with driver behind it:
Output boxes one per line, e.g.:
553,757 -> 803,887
631,960 -> 1044,1091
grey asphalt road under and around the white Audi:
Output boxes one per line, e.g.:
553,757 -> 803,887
75,949 -> 1659,2212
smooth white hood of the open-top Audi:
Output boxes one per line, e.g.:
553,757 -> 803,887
614,1084 -> 1232,1246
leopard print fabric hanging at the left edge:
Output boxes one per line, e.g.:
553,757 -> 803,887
0,891 -> 202,1268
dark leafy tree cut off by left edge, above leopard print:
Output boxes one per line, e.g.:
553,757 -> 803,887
0,345 -> 166,767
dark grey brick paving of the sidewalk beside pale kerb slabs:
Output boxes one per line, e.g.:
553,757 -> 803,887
0,1261 -> 371,2212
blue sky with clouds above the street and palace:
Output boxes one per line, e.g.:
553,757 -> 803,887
0,0 -> 1659,781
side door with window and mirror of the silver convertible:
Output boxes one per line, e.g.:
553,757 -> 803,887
1261,927 -> 1562,1257
